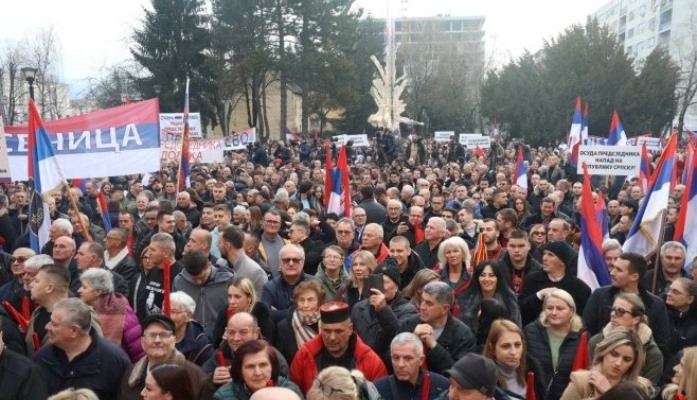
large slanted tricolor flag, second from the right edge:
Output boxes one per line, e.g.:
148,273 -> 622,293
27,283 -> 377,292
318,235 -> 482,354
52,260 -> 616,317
622,135 -> 678,257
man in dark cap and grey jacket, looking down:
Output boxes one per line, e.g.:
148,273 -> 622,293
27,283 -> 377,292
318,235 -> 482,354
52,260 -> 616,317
172,251 -> 232,337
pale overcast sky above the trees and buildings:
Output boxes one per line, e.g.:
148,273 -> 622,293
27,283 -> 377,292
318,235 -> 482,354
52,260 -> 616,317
0,0 -> 609,94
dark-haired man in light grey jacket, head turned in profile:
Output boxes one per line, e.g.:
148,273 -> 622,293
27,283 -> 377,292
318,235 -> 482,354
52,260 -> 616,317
217,225 -> 269,295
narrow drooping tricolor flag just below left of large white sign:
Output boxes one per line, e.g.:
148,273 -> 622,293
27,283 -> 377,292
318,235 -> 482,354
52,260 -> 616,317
577,163 -> 610,290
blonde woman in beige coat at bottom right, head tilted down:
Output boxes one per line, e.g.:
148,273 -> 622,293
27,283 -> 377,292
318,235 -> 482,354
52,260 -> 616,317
561,328 -> 654,400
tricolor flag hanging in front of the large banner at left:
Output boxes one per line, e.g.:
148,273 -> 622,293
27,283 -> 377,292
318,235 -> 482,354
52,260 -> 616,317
27,100 -> 67,254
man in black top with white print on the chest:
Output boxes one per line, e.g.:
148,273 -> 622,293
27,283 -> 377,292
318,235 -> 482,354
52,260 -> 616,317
128,233 -> 184,321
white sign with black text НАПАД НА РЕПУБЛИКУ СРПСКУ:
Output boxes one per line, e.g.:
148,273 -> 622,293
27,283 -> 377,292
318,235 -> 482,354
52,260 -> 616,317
576,145 -> 641,176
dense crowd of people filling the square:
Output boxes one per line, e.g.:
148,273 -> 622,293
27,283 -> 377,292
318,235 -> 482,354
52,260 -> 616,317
0,133 -> 697,400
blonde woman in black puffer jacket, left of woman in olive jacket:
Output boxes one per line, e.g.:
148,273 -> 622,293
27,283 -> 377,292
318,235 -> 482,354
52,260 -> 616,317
525,289 -> 583,399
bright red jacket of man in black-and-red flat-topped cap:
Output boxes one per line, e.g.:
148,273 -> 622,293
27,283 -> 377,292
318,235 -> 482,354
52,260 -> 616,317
290,335 -> 387,393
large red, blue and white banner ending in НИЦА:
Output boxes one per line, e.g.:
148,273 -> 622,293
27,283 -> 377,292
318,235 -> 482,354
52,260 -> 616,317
5,99 -> 160,181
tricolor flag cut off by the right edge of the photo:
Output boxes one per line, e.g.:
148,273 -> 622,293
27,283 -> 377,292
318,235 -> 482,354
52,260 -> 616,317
674,143 -> 697,268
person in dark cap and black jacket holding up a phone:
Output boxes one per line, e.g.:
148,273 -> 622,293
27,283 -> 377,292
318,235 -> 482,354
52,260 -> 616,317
351,260 -> 416,362
